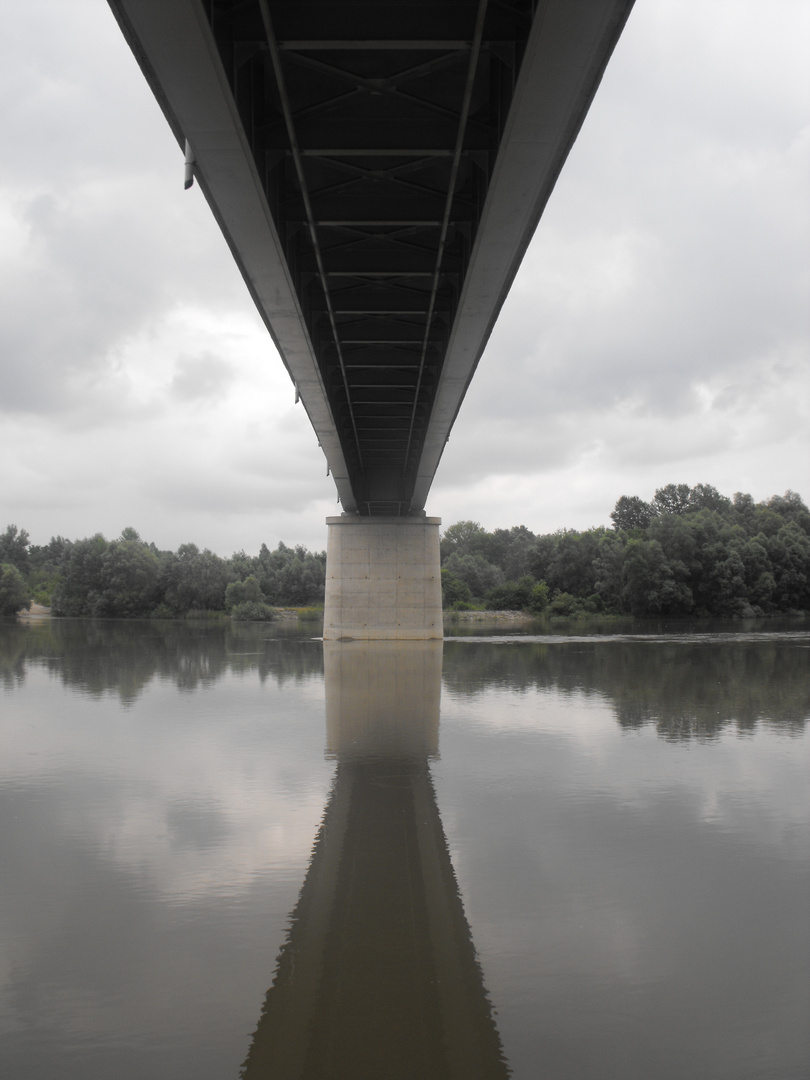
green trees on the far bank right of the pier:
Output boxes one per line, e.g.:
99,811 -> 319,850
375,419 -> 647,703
442,484 -> 810,617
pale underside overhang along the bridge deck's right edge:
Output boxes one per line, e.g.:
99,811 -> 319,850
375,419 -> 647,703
410,0 -> 635,511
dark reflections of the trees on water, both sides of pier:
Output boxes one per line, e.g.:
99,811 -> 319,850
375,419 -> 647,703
0,619 -> 810,741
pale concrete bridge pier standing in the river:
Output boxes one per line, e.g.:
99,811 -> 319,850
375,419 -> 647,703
323,514 -> 443,642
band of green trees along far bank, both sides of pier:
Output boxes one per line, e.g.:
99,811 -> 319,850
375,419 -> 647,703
0,484 -> 810,623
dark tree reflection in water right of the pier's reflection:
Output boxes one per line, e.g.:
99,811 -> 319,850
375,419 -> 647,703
444,633 -> 810,741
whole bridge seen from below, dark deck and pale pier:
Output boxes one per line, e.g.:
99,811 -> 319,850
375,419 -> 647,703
109,0 -> 633,638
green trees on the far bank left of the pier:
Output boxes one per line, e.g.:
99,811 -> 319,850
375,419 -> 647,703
0,525 -> 326,620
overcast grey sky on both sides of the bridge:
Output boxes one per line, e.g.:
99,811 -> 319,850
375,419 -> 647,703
0,0 -> 810,555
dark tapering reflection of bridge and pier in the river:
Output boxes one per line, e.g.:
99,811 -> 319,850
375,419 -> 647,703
241,642 -> 509,1080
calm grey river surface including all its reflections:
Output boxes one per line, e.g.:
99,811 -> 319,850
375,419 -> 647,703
0,620 -> 810,1080
